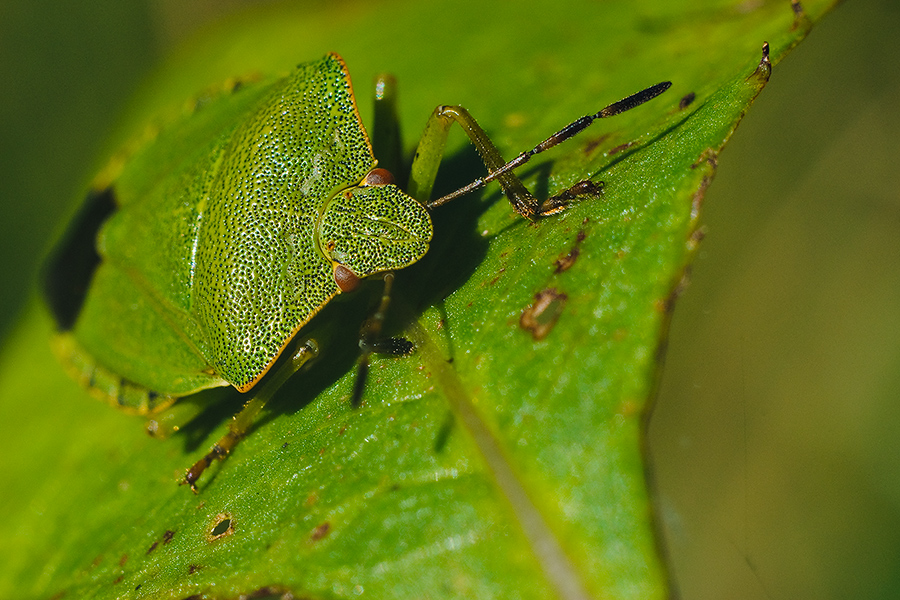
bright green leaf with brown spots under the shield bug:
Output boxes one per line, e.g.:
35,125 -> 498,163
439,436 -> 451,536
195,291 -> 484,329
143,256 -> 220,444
0,1 -> 830,598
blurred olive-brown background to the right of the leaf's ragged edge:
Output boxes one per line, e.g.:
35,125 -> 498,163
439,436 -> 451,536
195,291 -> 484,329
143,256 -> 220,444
650,0 -> 900,599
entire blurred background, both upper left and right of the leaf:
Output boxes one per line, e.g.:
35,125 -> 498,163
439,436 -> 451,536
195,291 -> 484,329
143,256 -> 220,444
0,0 -> 900,600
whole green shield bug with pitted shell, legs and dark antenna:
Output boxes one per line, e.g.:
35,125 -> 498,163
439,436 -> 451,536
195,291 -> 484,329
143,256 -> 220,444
44,54 -> 669,491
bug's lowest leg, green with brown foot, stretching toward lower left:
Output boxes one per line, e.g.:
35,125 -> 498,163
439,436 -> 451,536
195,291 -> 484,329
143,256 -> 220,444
181,340 -> 319,493
